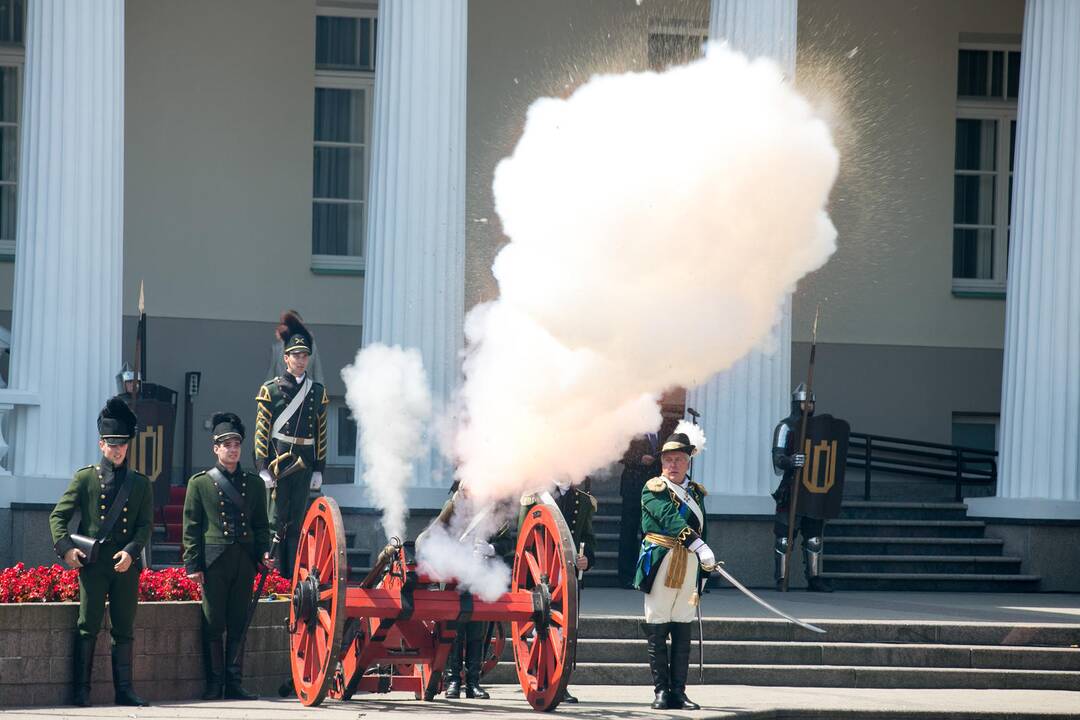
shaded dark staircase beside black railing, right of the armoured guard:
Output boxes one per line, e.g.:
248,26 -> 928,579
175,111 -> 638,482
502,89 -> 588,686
823,500 -> 1039,593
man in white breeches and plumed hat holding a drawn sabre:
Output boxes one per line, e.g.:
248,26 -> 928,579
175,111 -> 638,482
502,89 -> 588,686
634,433 -> 716,710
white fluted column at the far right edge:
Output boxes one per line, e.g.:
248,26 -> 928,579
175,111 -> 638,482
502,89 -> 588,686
968,0 -> 1080,519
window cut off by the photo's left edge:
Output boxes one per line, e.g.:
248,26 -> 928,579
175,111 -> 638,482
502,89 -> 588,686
0,0 -> 26,259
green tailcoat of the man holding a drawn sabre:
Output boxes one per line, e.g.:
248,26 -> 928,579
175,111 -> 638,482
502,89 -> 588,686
634,477 -> 708,593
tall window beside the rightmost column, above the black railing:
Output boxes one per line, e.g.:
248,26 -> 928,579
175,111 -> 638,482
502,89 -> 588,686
953,45 -> 1021,297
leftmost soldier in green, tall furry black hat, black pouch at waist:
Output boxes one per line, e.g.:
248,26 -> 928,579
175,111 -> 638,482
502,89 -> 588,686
49,397 -> 153,707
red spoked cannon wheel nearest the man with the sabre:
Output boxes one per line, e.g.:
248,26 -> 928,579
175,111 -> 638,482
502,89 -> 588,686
510,504 -> 578,711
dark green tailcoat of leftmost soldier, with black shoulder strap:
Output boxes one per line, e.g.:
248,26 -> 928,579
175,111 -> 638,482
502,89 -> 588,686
49,463 -> 153,565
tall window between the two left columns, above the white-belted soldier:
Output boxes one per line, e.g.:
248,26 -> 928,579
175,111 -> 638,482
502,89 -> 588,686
311,6 -> 378,273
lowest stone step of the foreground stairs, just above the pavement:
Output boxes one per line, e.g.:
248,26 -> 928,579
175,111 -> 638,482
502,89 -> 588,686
486,662 -> 1080,697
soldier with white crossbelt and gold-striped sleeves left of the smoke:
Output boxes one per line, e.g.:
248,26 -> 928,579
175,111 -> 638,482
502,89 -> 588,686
255,311 -> 329,578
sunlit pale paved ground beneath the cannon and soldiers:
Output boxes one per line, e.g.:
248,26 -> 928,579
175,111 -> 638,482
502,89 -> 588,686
0,685 -> 1080,720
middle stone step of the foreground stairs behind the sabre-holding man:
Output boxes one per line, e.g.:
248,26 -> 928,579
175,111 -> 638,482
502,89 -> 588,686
577,638 -> 1080,671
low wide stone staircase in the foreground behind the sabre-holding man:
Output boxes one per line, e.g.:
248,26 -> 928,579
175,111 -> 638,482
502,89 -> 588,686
489,616 -> 1080,696
